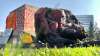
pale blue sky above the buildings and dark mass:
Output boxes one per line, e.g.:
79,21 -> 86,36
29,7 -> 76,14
0,0 -> 100,31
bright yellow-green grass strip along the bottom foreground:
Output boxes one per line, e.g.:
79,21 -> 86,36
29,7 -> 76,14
0,45 -> 100,56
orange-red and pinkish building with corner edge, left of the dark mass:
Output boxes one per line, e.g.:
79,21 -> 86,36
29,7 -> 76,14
6,4 -> 37,35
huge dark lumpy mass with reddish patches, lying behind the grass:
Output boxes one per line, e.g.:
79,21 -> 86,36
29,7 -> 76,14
35,8 -> 86,47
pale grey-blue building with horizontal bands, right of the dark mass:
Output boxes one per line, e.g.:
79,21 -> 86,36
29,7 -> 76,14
76,15 -> 94,37
